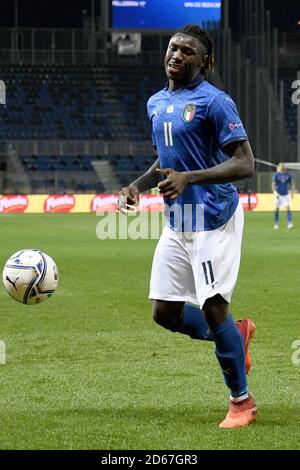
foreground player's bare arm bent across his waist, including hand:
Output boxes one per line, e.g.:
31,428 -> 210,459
157,140 -> 254,199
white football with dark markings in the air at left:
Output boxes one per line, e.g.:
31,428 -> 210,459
3,249 -> 58,305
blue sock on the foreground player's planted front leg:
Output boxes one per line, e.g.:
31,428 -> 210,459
212,316 -> 248,397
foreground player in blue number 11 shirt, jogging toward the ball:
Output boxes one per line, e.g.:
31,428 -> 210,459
119,25 -> 257,428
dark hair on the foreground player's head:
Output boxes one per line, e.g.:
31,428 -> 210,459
173,24 -> 215,79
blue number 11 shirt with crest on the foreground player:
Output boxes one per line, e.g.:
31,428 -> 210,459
147,75 -> 248,232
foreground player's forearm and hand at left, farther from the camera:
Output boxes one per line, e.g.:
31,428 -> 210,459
118,159 -> 160,214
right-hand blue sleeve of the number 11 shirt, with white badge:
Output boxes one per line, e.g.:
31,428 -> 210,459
207,93 -> 248,147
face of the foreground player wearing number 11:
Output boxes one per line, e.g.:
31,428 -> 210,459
165,34 -> 205,87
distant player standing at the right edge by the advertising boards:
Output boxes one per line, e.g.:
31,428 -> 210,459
272,163 -> 295,230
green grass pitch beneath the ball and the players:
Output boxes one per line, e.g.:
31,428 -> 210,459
0,213 -> 300,450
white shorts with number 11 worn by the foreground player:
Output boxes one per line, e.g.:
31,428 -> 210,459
149,203 -> 244,308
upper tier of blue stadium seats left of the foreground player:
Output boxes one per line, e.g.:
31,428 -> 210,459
0,65 -> 164,140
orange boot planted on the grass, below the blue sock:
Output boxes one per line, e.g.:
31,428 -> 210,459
219,395 -> 257,429
